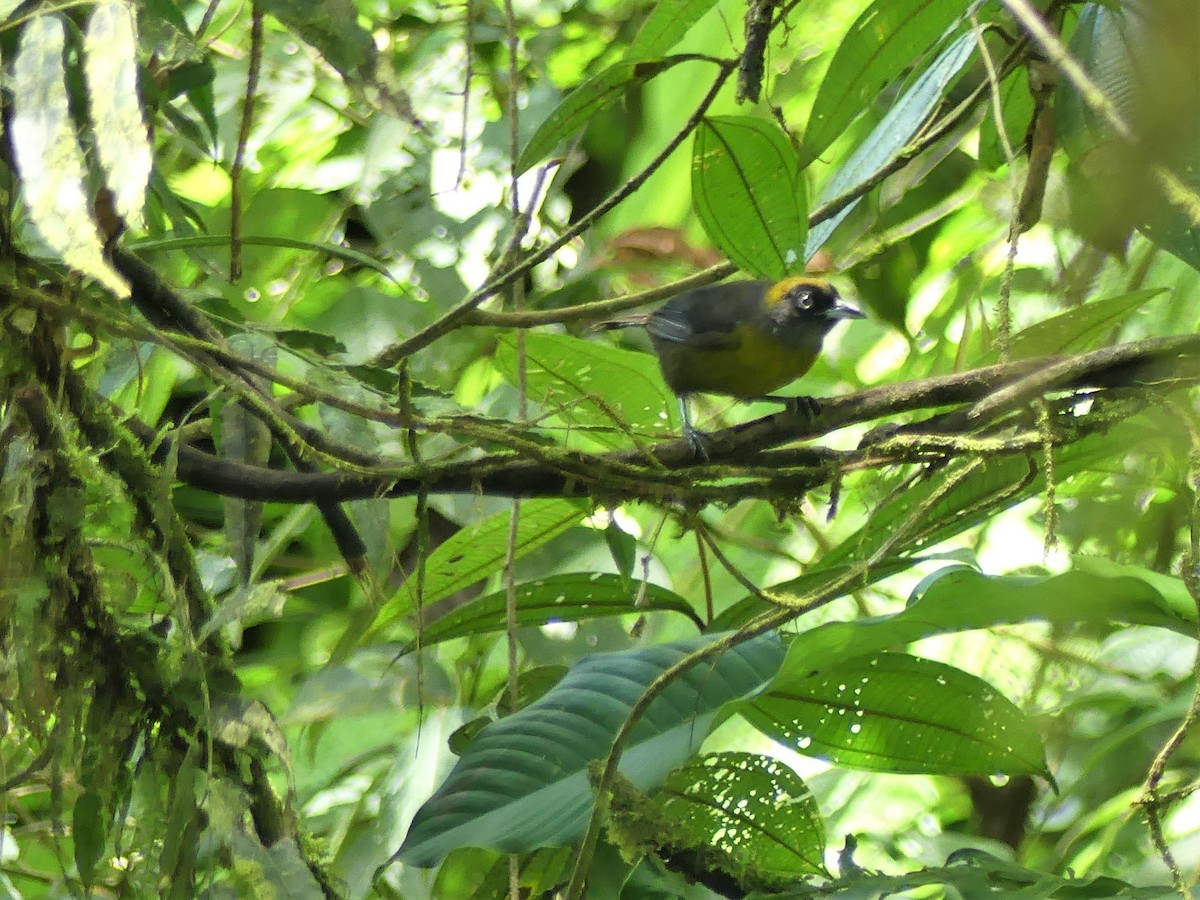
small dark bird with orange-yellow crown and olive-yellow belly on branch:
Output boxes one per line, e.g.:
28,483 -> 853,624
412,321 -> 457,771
596,275 -> 865,457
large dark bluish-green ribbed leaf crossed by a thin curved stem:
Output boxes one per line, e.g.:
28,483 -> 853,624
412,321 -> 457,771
394,635 -> 781,868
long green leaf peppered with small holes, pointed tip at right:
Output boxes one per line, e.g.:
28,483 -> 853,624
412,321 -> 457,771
740,653 -> 1049,778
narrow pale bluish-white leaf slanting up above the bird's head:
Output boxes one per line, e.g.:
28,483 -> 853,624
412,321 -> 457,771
806,31 -> 976,258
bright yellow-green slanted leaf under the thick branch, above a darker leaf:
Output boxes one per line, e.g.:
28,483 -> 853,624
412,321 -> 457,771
376,499 -> 588,629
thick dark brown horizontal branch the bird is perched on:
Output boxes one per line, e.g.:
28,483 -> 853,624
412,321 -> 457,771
110,335 -> 1200,503
